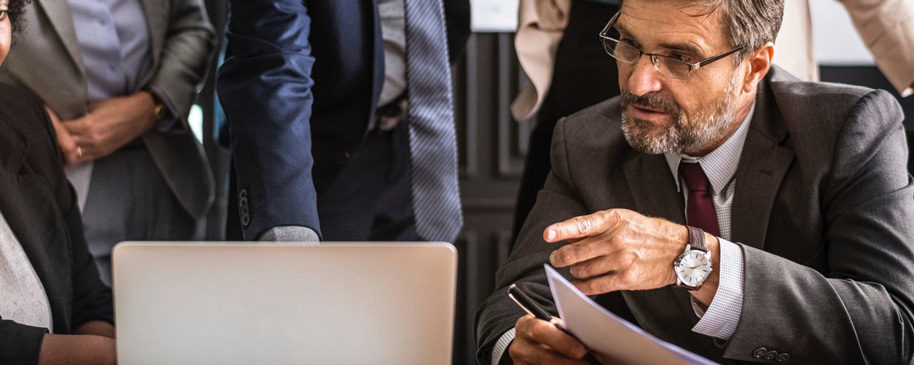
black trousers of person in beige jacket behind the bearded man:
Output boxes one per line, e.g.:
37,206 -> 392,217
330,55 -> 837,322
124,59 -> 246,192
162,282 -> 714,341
511,0 -> 619,242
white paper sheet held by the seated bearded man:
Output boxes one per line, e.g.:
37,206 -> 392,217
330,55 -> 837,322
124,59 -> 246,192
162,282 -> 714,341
543,264 -> 715,364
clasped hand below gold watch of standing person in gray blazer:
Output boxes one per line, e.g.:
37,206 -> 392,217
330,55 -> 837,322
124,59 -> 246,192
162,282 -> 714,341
63,91 -> 156,162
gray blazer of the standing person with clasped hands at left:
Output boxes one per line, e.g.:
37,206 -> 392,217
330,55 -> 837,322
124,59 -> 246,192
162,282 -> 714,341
0,0 -> 215,219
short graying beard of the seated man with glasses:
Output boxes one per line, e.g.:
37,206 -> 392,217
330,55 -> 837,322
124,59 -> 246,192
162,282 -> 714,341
622,78 -> 741,155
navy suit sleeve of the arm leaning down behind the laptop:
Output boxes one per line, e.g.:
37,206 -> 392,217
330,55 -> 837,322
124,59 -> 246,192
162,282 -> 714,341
216,0 -> 320,240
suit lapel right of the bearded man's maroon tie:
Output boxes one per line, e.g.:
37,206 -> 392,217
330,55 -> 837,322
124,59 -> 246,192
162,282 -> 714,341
731,82 -> 795,249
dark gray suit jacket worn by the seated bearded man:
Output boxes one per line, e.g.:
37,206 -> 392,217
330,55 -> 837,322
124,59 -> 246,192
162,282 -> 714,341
476,67 -> 914,364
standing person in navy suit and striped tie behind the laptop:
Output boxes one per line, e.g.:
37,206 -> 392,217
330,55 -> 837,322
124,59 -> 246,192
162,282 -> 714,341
217,0 -> 469,241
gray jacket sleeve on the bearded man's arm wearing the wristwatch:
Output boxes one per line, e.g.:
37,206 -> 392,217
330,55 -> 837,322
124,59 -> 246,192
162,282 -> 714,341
724,91 -> 914,364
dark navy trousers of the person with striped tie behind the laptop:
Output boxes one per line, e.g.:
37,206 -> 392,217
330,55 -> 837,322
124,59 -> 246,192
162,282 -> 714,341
226,122 -> 421,241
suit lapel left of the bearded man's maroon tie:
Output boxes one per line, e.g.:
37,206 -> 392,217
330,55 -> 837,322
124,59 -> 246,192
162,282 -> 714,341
622,153 -> 685,224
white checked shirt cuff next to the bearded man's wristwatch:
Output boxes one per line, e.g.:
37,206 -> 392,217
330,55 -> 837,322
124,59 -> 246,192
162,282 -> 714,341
692,238 -> 745,340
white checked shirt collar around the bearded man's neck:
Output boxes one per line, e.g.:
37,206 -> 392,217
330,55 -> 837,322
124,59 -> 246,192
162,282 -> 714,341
663,102 -> 755,194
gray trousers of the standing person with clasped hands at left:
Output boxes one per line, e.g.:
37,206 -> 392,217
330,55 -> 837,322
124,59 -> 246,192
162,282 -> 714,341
83,143 -> 204,285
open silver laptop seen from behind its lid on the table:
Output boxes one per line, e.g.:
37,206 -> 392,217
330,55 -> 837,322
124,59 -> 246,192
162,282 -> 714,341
112,242 -> 457,364
